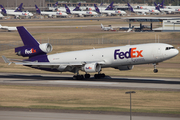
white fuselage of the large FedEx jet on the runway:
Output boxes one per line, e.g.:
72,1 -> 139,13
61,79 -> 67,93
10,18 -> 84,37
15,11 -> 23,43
48,43 -> 179,67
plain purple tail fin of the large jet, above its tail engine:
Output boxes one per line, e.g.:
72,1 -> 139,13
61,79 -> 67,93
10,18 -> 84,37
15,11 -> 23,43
17,26 -> 39,46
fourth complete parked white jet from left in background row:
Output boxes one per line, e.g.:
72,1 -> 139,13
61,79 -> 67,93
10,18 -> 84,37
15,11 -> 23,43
94,4 -> 126,15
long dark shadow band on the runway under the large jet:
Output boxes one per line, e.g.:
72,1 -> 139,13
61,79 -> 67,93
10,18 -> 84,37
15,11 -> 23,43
0,75 -> 180,84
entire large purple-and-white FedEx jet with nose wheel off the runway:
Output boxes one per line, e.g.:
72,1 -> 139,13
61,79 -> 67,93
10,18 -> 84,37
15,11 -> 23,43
2,26 -> 179,79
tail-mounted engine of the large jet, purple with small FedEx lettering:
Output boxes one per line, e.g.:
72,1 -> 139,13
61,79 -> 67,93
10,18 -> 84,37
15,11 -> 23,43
15,43 -> 53,57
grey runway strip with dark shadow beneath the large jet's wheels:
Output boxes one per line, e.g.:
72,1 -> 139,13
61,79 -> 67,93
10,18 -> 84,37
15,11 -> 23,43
0,73 -> 180,90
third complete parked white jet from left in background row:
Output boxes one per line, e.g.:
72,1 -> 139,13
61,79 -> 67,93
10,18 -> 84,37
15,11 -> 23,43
65,4 -> 97,17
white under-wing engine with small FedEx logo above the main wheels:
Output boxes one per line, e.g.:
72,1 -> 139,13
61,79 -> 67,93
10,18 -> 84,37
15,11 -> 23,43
82,63 -> 101,73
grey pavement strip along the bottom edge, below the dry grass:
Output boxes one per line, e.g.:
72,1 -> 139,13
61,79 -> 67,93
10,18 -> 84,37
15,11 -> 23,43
0,111 -> 179,120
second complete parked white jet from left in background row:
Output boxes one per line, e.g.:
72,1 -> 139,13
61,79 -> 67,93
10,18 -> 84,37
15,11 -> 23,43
35,5 -> 67,17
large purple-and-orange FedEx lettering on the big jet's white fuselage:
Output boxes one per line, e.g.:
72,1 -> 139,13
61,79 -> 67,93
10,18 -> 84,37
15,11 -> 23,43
114,48 -> 143,60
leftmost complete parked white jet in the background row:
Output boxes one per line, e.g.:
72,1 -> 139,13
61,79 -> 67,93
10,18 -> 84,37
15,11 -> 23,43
0,5 -> 33,18
